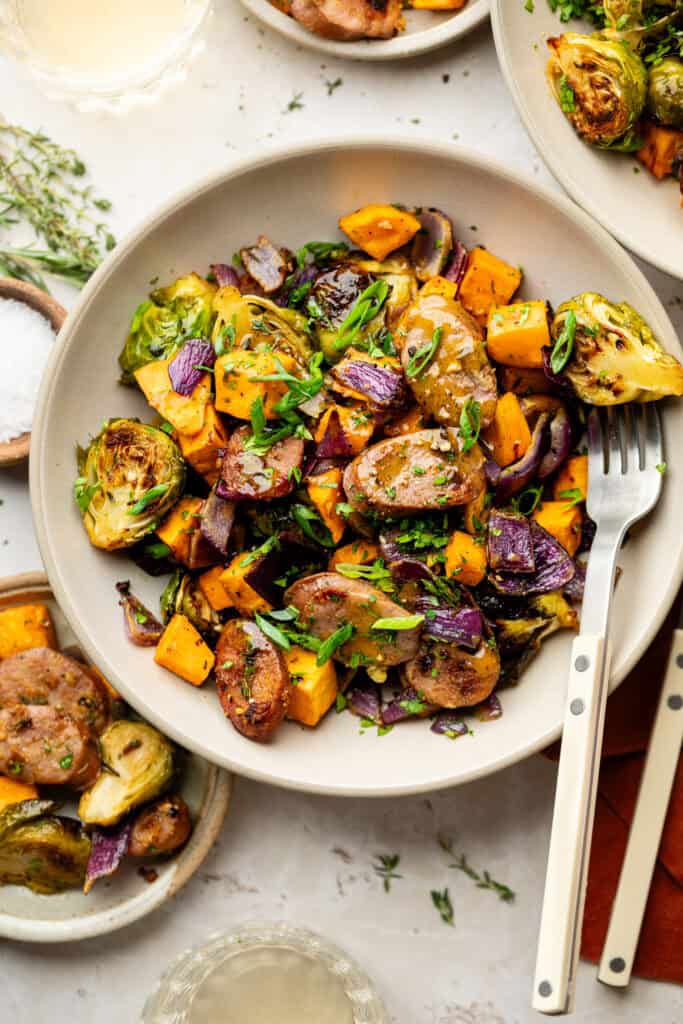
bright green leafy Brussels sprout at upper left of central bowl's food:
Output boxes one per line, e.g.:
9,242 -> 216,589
119,273 -> 216,384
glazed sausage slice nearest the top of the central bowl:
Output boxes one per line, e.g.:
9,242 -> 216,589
397,294 -> 498,427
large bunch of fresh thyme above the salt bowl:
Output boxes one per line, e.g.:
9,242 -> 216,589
0,122 -> 116,288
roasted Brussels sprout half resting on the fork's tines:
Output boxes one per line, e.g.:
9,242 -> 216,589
551,292 -> 683,406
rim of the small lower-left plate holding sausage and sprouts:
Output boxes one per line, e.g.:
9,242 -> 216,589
0,571 -> 234,943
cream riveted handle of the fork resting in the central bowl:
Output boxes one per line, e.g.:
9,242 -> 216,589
532,635 -> 609,1014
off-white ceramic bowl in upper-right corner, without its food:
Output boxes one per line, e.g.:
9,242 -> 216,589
492,0 -> 683,280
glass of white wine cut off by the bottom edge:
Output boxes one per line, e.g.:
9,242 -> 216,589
142,924 -> 388,1024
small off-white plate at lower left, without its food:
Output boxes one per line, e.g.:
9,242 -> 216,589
0,572 -> 232,942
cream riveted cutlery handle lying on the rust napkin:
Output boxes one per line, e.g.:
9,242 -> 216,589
598,630 -> 683,988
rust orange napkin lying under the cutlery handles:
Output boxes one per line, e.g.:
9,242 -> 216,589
547,597 -> 683,984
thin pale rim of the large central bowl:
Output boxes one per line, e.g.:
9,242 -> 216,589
29,133 -> 683,797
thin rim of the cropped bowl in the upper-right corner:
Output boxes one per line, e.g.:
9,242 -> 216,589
490,0 -> 683,281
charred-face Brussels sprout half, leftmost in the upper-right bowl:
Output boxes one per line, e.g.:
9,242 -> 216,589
548,32 -> 647,151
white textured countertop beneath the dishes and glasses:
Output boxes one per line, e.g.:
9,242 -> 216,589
0,0 -> 683,1024
